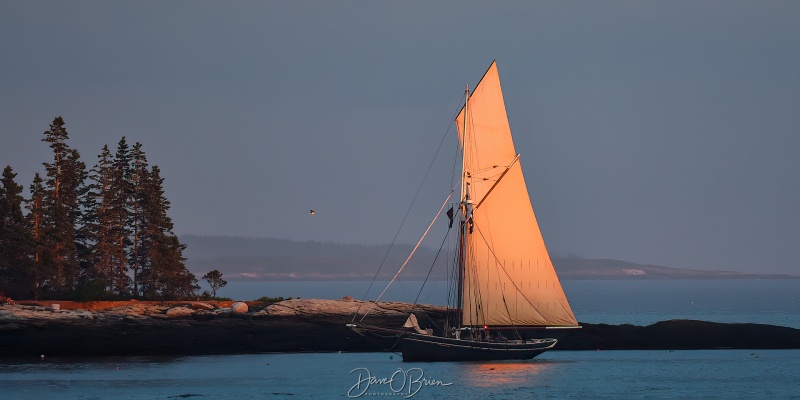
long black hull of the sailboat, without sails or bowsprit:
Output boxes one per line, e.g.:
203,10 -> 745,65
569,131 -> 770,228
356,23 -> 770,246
401,334 -> 556,362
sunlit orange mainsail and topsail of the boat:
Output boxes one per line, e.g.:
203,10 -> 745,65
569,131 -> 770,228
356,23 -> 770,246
456,62 -> 578,327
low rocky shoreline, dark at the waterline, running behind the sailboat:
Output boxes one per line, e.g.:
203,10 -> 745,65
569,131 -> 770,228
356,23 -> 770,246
0,299 -> 800,361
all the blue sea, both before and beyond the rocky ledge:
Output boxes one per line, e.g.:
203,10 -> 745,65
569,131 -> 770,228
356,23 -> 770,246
0,280 -> 800,400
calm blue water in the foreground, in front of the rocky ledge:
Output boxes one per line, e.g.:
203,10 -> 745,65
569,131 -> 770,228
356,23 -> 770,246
0,350 -> 800,400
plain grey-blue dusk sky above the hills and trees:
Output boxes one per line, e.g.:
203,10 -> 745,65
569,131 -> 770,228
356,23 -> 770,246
0,0 -> 800,275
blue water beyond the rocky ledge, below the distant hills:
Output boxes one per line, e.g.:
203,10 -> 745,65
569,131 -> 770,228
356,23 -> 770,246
218,279 -> 800,328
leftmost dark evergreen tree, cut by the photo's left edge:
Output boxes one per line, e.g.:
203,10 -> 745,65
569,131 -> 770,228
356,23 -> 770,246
0,166 -> 33,298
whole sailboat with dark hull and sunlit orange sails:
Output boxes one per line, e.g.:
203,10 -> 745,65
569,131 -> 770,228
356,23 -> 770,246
348,61 -> 580,361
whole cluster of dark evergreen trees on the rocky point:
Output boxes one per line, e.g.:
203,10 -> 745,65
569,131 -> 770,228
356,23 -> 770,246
0,117 -> 199,300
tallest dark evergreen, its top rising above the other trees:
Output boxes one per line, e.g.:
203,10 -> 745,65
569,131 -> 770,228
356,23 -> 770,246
42,117 -> 86,293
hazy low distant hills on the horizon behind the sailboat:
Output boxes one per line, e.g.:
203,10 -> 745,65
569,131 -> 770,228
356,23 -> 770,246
181,235 -> 798,281
